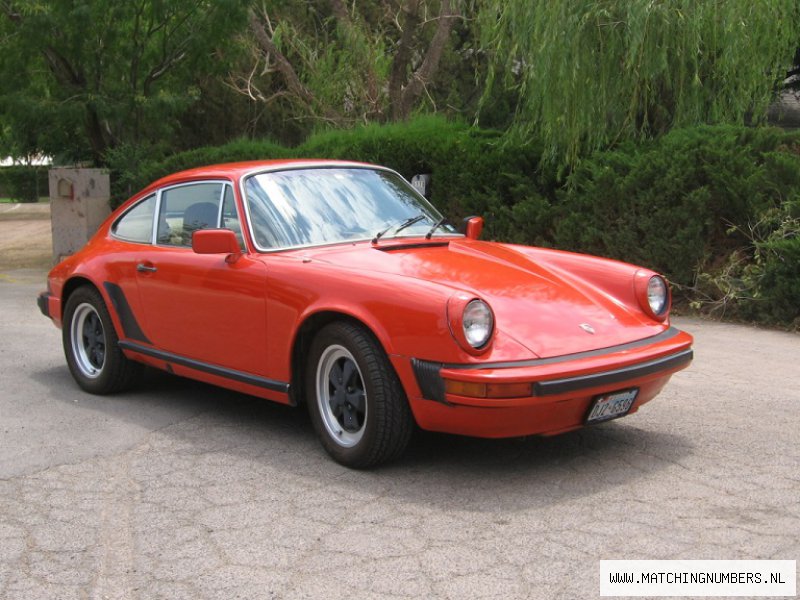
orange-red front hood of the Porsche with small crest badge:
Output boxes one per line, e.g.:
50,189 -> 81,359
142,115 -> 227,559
303,240 -> 666,358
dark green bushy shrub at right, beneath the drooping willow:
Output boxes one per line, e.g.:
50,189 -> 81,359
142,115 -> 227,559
553,126 -> 800,327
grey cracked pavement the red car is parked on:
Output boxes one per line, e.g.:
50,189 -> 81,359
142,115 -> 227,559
0,270 -> 800,600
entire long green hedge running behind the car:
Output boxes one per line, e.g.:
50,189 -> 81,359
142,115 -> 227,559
117,117 -> 800,327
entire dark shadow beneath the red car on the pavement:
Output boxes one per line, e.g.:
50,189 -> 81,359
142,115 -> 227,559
33,368 -> 694,513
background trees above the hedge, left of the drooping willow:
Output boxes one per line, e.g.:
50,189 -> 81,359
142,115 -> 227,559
0,0 -> 494,166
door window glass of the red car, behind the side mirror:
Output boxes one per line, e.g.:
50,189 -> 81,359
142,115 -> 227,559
157,182 -> 223,246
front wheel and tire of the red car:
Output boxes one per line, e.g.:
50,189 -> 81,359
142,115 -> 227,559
305,322 -> 414,469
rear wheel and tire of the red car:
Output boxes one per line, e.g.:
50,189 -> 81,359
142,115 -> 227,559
61,286 -> 142,394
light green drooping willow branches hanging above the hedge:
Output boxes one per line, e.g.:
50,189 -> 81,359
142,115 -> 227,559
482,0 -> 800,163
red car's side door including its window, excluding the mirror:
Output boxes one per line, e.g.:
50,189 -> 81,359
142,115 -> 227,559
136,181 -> 267,375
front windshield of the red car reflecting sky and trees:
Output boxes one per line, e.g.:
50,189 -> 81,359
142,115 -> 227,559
245,167 -> 455,250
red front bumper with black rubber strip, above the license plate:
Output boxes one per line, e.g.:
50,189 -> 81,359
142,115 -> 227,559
409,328 -> 693,437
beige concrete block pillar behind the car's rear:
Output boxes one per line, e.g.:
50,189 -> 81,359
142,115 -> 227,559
49,167 -> 111,261
